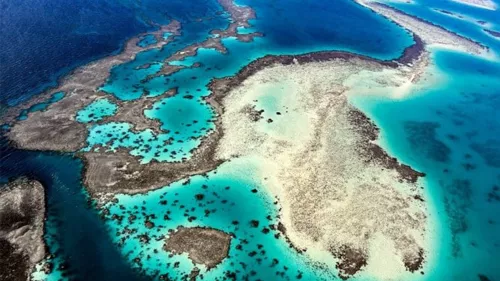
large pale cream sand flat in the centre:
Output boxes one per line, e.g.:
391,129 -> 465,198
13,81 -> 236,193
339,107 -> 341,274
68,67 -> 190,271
213,58 -> 428,278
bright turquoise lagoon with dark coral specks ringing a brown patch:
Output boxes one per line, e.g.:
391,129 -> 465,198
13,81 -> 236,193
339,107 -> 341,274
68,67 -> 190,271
102,160 -> 336,280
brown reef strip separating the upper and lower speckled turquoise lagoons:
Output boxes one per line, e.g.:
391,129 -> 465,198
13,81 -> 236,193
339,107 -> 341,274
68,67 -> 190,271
82,129 -> 223,197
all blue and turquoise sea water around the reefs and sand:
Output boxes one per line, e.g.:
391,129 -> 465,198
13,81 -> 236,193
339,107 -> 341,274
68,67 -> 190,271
0,0 -> 500,281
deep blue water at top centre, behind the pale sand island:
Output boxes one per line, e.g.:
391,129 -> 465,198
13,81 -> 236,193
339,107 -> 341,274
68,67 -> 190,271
236,0 -> 412,59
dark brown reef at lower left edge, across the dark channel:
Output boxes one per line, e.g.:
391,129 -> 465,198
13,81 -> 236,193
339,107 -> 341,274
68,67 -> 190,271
0,178 -> 46,280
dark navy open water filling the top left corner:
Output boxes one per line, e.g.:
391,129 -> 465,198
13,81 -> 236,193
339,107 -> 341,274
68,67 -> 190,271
0,0 -> 150,105
